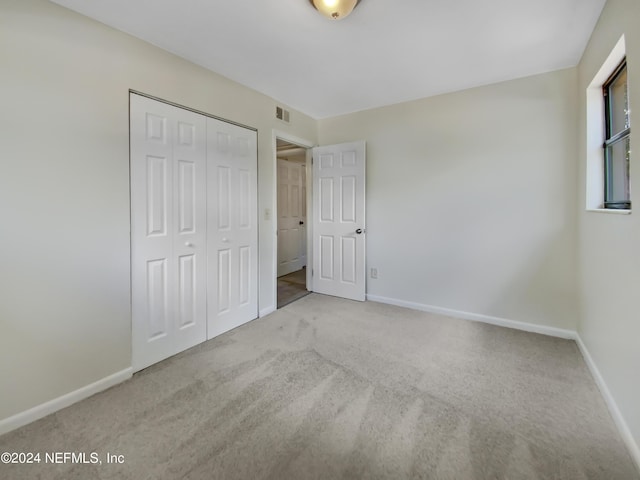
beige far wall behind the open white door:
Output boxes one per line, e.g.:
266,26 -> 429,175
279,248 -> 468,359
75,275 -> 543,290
319,69 -> 577,330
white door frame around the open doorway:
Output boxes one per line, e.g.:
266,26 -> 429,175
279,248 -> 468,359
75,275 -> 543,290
272,129 -> 316,316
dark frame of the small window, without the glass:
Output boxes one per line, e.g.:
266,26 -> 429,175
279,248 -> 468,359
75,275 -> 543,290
602,56 -> 631,210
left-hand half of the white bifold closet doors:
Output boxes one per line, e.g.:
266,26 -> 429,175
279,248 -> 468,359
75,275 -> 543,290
130,94 -> 207,371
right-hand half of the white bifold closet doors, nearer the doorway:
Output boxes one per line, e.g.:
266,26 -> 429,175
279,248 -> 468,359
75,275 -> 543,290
207,118 -> 258,338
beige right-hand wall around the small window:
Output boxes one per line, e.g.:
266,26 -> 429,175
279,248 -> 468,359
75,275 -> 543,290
578,0 -> 640,454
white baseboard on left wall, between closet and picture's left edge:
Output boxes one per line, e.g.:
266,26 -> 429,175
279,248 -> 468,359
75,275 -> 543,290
0,368 -> 133,435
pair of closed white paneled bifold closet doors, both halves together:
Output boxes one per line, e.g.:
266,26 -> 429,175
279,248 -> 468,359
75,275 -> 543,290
130,94 -> 257,371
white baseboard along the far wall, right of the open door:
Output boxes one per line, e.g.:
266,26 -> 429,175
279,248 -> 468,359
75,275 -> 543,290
367,295 -> 576,340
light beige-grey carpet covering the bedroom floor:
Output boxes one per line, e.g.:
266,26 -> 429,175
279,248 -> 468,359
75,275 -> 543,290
0,294 -> 639,480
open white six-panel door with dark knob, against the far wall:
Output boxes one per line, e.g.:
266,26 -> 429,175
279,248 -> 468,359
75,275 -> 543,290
313,142 -> 366,301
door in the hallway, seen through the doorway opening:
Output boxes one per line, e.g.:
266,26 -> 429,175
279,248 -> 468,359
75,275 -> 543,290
278,159 -> 306,277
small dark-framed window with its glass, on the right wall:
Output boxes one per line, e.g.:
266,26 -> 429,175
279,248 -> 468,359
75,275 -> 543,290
602,60 -> 631,210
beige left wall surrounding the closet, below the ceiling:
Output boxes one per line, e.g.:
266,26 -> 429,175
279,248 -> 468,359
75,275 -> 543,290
0,0 -> 316,419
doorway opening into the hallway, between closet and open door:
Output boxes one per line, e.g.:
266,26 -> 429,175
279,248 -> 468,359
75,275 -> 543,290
276,138 -> 311,308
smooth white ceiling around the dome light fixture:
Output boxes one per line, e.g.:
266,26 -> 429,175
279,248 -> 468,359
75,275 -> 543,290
52,0 -> 606,118
